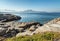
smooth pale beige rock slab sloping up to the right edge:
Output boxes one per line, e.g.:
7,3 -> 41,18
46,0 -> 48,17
34,18 -> 60,33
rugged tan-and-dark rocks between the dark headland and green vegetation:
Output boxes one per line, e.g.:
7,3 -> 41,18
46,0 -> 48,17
0,21 -> 40,37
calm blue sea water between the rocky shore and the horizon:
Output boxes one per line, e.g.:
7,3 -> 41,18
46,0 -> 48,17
15,13 -> 60,24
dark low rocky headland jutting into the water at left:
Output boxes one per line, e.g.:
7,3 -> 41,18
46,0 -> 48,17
0,14 -> 21,22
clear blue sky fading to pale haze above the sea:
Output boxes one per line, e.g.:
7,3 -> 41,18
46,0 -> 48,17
0,0 -> 60,12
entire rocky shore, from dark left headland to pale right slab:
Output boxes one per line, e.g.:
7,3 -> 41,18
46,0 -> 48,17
0,14 -> 60,40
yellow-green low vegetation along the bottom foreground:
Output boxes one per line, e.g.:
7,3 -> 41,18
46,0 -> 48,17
6,32 -> 60,41
